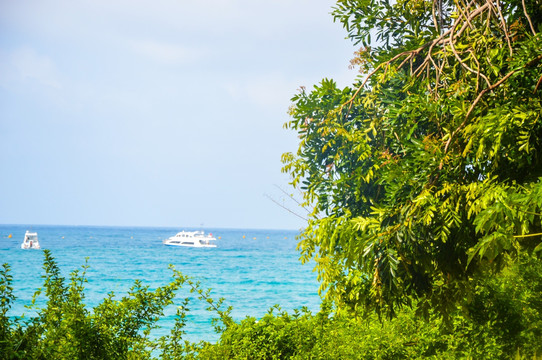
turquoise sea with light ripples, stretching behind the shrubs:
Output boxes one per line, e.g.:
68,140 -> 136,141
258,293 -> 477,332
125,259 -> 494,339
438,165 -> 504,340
0,225 -> 321,342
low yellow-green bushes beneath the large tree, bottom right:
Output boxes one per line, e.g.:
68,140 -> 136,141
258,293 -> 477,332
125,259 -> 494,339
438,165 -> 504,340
199,256 -> 542,359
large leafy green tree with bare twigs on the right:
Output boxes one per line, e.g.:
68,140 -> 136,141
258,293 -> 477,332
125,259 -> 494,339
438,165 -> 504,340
283,0 -> 542,315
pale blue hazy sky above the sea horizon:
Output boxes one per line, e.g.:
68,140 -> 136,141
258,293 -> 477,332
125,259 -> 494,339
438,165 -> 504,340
0,0 -> 357,229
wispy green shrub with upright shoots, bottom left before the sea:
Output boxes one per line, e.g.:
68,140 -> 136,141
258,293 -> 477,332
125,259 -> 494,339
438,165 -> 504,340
0,250 -> 229,360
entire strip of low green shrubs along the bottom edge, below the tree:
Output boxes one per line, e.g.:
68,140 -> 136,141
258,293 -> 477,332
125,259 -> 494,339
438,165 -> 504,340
0,252 -> 542,360
